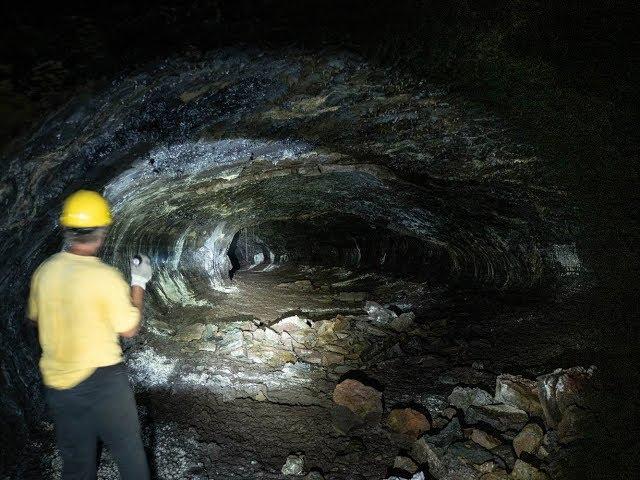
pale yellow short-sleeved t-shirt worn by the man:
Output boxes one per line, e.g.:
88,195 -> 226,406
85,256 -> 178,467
27,252 -> 140,389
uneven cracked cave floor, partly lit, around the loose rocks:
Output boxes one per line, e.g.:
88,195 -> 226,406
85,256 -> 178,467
21,267 -> 590,479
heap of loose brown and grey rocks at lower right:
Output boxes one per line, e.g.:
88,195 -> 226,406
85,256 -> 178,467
334,368 -> 593,480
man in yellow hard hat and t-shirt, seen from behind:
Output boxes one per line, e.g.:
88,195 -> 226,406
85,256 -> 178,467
27,190 -> 152,480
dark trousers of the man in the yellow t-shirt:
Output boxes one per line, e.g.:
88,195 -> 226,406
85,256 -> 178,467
47,363 -> 149,480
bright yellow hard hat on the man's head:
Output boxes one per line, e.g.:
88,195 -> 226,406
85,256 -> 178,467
60,190 -> 113,228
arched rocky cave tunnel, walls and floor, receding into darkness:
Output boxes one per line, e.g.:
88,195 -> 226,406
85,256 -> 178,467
0,2 -> 635,480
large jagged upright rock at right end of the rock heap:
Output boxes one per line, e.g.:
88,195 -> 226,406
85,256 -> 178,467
537,367 -> 595,443
